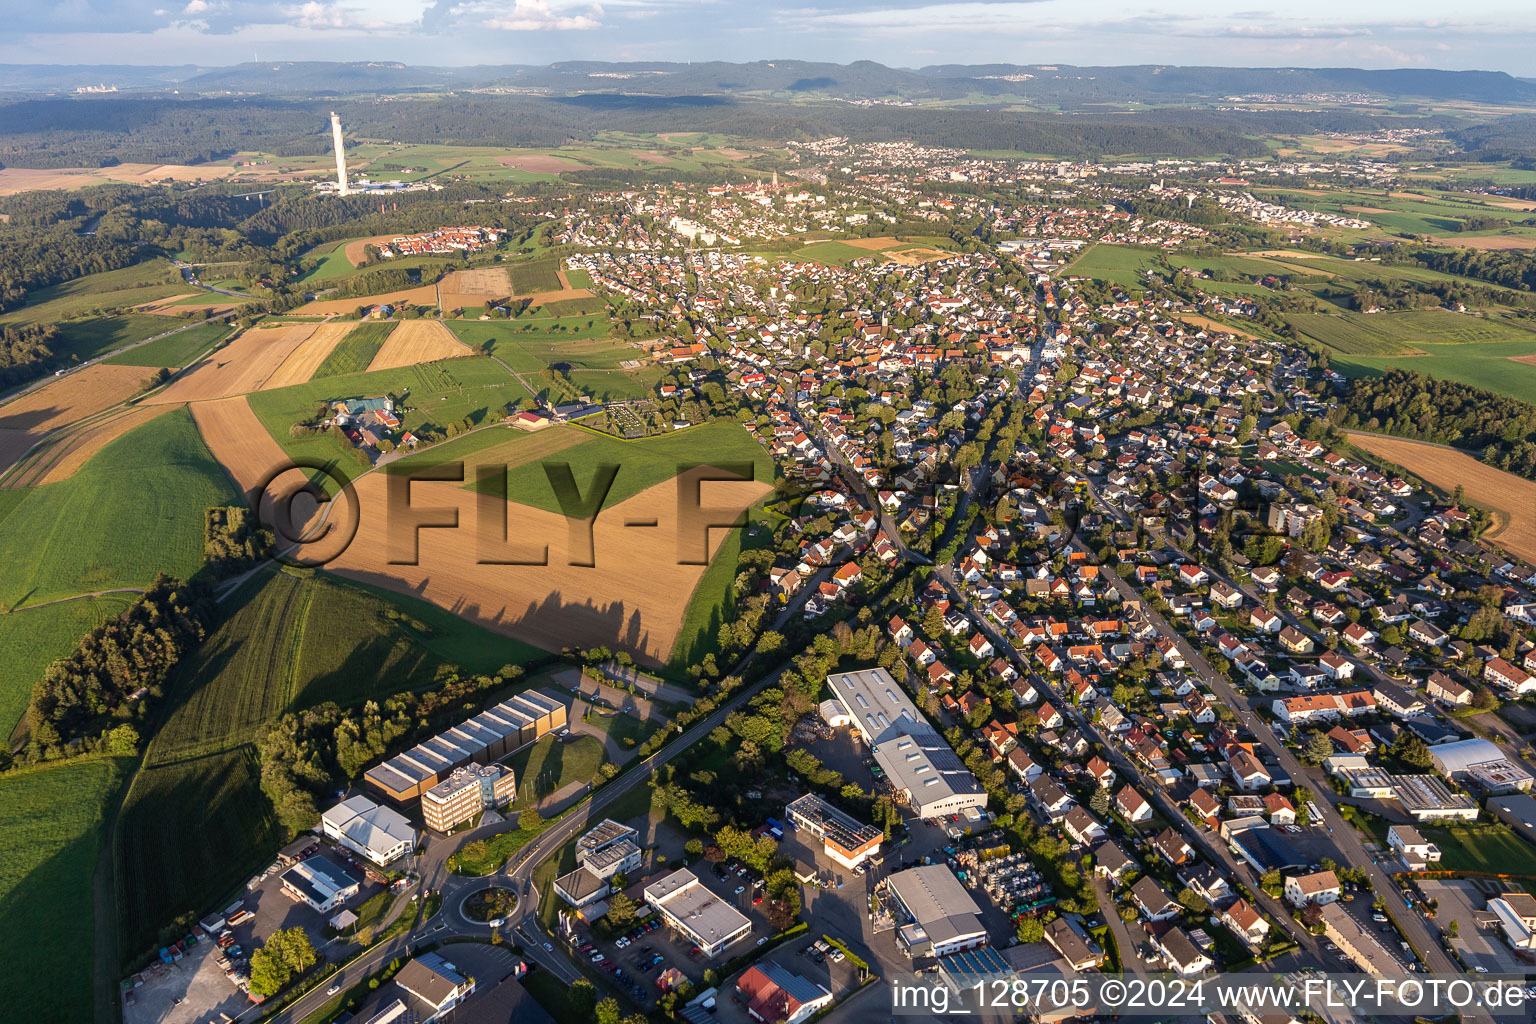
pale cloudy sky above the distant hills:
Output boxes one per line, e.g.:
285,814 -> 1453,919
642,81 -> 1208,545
0,0 -> 1536,75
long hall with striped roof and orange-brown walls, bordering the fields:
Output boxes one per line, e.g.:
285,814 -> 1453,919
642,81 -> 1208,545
362,689 -> 568,806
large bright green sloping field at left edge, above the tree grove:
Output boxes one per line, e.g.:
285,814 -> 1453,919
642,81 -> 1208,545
0,408 -> 243,606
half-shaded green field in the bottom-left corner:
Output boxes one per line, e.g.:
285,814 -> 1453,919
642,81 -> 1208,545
0,758 -> 131,1024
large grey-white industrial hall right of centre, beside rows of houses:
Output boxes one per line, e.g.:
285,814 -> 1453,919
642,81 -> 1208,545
826,668 -> 986,818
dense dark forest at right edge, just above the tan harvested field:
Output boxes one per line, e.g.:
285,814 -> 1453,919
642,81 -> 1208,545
1338,370 -> 1536,479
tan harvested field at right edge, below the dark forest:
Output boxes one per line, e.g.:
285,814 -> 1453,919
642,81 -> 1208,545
1346,430 -> 1536,562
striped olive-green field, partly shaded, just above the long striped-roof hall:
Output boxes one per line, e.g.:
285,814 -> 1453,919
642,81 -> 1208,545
146,571 -> 541,765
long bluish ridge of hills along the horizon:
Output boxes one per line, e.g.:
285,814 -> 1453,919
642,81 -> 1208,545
0,60 -> 1536,109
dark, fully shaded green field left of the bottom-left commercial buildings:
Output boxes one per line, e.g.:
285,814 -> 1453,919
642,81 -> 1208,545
115,748 -> 283,963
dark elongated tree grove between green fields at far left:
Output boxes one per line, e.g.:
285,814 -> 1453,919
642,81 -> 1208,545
26,573 -> 207,760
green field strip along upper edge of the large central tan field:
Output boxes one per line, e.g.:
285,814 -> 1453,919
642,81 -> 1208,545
470,421 -> 773,511
